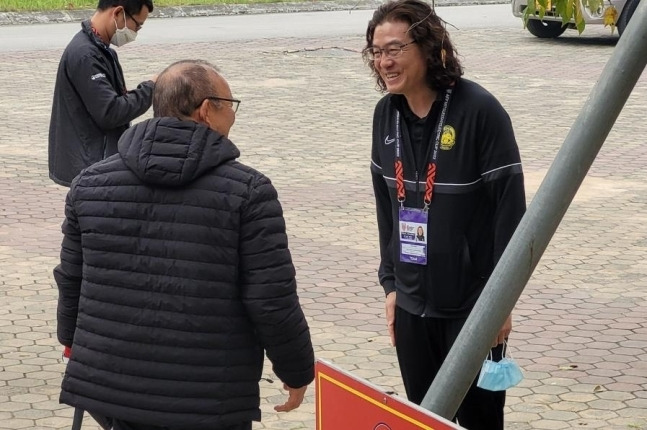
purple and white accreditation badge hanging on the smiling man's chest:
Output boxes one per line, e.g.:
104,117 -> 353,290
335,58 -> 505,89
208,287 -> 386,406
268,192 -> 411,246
398,207 -> 429,265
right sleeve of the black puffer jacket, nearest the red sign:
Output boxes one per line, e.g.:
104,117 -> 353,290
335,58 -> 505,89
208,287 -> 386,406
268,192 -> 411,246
240,175 -> 314,388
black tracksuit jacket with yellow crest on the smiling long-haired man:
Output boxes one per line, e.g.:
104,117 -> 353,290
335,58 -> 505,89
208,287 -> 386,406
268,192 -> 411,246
371,79 -> 526,318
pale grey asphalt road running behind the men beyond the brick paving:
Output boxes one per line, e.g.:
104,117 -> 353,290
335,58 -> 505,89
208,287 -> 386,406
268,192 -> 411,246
0,4 -> 522,52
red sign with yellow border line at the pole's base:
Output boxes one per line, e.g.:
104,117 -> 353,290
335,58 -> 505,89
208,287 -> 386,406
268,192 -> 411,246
315,360 -> 462,430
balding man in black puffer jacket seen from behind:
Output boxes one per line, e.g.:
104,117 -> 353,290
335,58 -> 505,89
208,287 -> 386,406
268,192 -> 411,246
54,61 -> 314,430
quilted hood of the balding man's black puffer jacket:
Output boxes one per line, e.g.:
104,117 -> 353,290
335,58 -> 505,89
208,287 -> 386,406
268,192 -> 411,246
119,117 -> 240,187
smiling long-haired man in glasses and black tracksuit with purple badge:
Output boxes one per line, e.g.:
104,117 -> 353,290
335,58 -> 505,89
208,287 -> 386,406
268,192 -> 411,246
364,0 -> 525,430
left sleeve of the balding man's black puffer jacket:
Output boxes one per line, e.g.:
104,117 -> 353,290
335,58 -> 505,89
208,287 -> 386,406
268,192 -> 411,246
54,182 -> 83,347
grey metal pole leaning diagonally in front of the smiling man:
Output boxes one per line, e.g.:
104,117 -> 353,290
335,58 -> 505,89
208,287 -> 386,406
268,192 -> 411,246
421,1 -> 647,420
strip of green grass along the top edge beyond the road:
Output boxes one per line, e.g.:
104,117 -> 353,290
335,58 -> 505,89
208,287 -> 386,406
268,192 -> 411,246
0,0 -> 294,12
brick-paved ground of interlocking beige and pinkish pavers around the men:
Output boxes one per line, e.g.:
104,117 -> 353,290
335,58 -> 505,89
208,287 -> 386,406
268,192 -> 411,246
0,13 -> 647,430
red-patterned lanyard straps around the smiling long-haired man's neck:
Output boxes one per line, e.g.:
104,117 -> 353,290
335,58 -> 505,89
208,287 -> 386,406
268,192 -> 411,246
395,88 -> 452,210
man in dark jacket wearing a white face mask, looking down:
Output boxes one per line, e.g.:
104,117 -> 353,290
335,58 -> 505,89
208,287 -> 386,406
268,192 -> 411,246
49,0 -> 155,186
